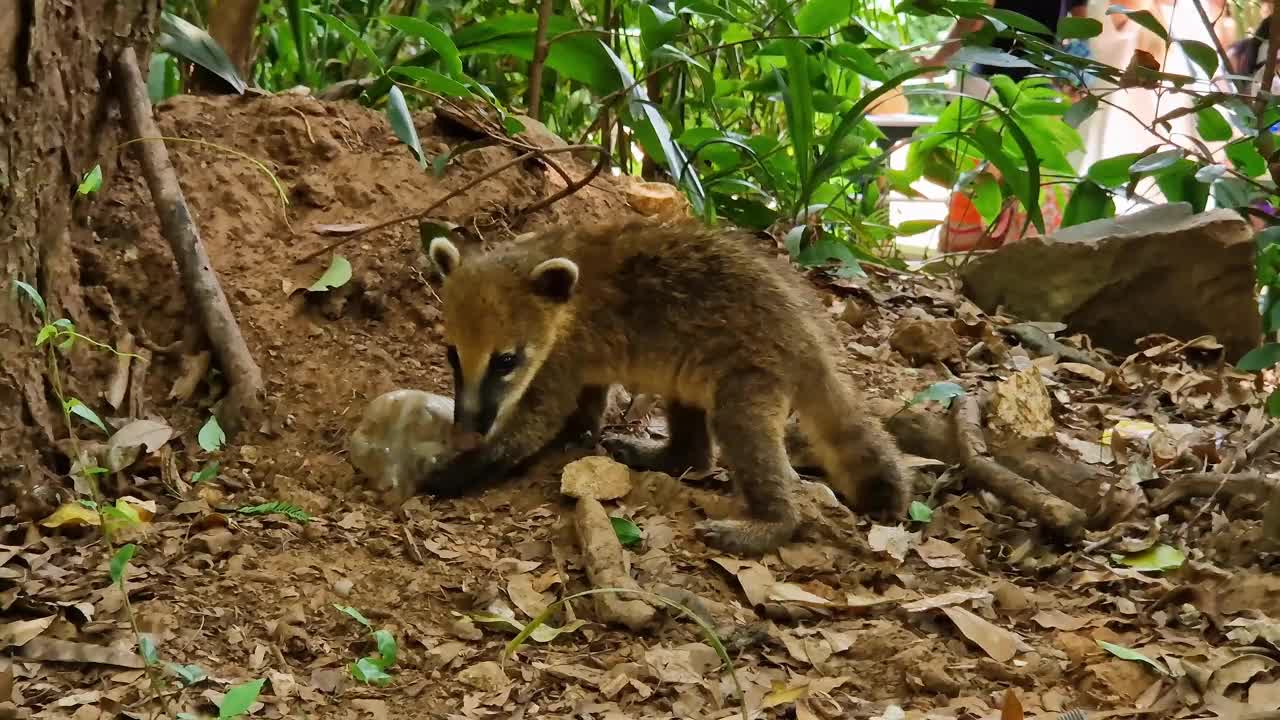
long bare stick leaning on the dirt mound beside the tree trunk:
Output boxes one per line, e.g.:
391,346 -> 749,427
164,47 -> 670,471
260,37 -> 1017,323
116,47 -> 264,433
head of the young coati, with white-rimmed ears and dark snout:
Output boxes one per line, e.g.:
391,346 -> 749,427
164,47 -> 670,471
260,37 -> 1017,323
429,237 -> 579,447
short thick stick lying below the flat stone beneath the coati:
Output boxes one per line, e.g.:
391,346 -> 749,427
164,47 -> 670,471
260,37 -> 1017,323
573,497 -> 657,630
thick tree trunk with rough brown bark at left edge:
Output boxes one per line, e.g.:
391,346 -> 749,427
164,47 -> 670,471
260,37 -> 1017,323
0,0 -> 163,516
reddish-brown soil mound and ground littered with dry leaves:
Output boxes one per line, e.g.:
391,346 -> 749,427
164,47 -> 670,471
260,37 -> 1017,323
0,96 -> 1280,720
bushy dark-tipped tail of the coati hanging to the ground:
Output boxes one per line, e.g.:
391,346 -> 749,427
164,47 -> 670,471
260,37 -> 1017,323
795,368 -> 911,519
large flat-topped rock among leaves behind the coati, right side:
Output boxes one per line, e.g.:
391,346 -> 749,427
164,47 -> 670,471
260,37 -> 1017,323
960,202 -> 1262,361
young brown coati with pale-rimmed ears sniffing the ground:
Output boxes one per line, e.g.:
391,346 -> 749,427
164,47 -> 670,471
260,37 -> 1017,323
424,220 -> 910,553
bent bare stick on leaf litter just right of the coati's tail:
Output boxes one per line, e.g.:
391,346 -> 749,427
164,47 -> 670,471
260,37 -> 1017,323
951,395 -> 1087,539
